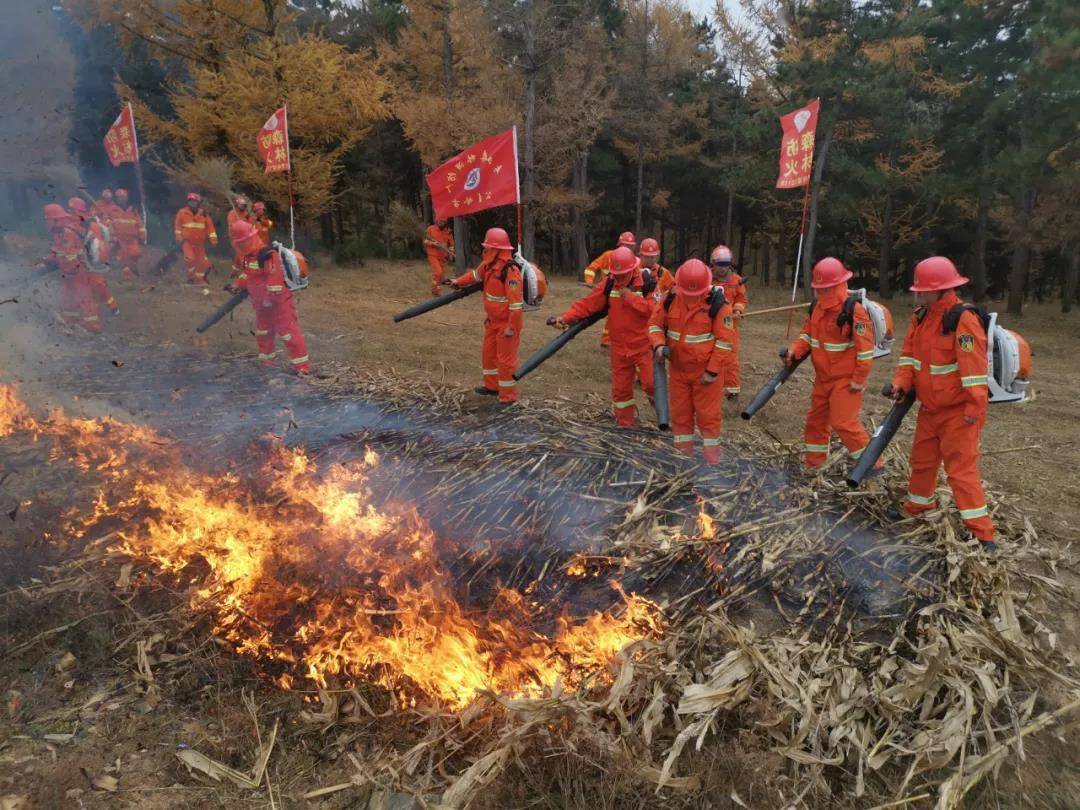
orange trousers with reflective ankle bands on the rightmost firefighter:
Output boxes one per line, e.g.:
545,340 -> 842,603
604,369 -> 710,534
904,405 -> 994,541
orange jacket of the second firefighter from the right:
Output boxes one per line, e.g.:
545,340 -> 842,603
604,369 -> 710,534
787,284 -> 874,384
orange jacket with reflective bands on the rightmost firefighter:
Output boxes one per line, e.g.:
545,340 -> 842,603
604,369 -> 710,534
892,289 -> 988,419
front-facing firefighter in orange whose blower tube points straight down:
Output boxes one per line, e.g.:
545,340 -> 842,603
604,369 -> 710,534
649,259 -> 734,464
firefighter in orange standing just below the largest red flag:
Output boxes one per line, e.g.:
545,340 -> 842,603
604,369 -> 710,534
449,228 -> 525,407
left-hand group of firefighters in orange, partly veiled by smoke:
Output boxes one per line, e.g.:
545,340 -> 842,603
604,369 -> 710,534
44,188 -> 311,374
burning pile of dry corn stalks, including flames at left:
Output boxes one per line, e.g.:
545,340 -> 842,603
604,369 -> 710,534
0,377 -> 1080,808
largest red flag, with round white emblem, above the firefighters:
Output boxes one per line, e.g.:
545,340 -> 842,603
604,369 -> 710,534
427,126 -> 522,219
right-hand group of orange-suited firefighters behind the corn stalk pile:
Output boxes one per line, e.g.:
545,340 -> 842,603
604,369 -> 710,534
424,221 -> 995,549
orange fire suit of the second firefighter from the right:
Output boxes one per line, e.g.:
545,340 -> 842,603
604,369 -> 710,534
787,284 -> 881,468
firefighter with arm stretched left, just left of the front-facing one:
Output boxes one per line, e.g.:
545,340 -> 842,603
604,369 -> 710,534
550,247 -> 654,428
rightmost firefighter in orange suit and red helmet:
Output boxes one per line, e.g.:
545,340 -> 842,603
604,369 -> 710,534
886,256 -> 996,550
